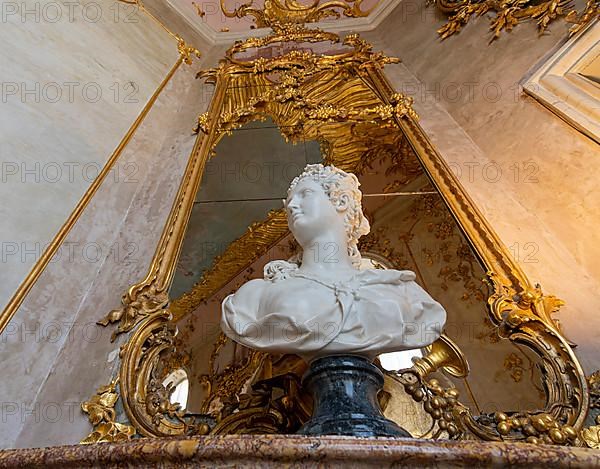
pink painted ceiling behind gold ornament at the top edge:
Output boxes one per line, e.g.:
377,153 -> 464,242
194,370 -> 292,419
169,0 -> 381,33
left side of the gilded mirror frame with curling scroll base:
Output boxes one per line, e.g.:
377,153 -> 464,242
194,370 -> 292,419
84,73 -> 225,436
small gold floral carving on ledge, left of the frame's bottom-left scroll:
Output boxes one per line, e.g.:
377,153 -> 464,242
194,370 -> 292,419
81,380 -> 136,445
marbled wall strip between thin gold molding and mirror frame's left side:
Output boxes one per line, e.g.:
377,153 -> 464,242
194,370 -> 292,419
0,54 -> 211,447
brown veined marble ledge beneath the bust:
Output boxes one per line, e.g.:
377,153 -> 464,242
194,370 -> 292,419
0,435 -> 600,469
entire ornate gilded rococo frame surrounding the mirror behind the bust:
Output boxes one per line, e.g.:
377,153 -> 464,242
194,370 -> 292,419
82,1 -> 589,445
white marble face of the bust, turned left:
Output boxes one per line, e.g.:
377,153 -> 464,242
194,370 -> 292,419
286,178 -> 345,245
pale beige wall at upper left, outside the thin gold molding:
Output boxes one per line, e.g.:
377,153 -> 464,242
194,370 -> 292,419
0,0 -> 177,309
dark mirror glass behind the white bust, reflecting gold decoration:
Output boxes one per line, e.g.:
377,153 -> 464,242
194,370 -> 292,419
165,114 -> 545,431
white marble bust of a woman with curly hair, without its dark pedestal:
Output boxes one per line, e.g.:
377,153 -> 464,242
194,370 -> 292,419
221,164 -> 446,362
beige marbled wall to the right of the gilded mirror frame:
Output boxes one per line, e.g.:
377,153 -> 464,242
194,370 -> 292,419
364,0 -> 600,372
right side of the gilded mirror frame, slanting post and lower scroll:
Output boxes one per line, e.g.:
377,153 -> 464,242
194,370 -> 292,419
368,67 -> 589,428
